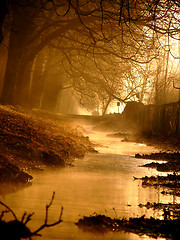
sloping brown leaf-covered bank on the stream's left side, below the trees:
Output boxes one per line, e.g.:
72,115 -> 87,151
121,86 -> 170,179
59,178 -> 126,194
0,106 -> 94,187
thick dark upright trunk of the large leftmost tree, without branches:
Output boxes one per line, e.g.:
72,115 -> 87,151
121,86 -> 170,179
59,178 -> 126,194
1,4 -> 39,104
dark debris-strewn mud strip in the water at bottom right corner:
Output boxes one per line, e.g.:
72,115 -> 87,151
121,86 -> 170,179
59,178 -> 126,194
76,214 -> 180,240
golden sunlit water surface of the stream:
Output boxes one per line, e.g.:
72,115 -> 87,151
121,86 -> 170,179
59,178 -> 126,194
1,130 -> 173,240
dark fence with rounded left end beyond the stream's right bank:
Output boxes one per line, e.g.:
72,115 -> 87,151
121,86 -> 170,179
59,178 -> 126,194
124,101 -> 180,134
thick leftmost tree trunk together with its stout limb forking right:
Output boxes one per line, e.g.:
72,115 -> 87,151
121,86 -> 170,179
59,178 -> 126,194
1,1 -> 79,105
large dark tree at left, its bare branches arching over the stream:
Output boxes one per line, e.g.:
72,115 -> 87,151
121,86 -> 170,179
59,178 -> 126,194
0,0 -> 180,109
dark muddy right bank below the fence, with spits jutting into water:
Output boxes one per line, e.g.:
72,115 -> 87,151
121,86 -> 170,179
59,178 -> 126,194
108,129 -> 180,172
